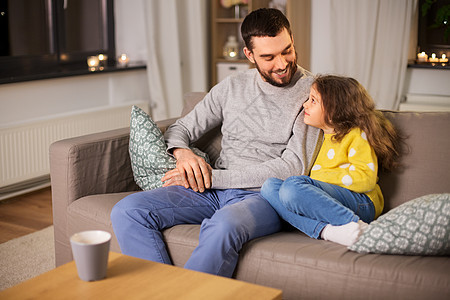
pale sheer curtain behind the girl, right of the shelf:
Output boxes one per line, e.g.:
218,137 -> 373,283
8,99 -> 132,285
312,0 -> 417,109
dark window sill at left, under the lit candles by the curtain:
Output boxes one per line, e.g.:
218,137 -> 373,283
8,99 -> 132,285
0,62 -> 147,84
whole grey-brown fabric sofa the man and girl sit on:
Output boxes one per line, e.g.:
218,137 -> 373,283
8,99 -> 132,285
50,92 -> 450,299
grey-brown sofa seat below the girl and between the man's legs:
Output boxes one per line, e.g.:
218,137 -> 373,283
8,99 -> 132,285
164,225 -> 450,299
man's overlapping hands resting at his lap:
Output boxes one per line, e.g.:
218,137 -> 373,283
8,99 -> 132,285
161,148 -> 212,193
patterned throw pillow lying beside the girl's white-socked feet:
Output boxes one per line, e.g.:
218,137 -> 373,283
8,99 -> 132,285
348,194 -> 450,255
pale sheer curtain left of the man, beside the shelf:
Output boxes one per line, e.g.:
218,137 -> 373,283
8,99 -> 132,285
144,0 -> 208,120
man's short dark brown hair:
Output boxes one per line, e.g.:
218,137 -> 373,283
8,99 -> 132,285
241,8 -> 292,51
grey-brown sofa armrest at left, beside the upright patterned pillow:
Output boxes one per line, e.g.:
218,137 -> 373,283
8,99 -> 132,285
50,119 -> 176,264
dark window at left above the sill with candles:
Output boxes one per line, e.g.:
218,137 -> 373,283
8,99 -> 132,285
0,0 -> 115,78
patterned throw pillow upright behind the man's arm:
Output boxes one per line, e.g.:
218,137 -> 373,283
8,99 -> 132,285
129,106 -> 209,190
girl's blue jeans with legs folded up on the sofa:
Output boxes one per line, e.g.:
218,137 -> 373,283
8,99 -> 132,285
261,176 -> 375,239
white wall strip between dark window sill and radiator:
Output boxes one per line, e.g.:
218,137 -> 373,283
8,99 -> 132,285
0,69 -> 149,128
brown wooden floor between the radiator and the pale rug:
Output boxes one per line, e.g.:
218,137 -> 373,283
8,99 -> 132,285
0,187 -> 53,243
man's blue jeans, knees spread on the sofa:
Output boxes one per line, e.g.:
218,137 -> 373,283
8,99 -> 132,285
111,186 -> 281,277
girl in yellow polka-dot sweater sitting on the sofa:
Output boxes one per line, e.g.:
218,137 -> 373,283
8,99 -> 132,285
261,75 -> 399,246
